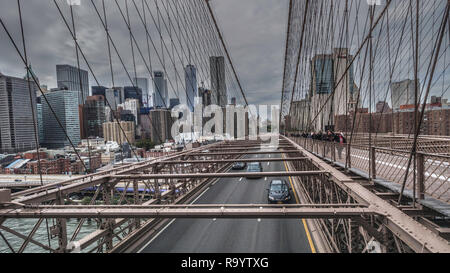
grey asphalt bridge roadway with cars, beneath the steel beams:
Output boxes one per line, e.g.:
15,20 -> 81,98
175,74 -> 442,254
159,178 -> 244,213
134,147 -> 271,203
140,152 -> 314,253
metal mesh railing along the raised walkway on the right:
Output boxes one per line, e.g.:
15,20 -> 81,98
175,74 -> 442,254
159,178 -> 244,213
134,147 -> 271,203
292,137 -> 450,203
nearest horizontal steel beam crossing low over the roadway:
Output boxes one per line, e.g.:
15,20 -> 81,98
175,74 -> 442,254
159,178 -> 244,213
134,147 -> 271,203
0,206 -> 380,219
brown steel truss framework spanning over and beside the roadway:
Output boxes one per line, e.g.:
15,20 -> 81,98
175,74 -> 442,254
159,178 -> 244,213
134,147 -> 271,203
0,137 -> 450,253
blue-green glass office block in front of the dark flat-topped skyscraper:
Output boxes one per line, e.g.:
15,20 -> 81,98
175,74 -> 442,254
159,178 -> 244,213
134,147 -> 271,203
42,90 -> 80,148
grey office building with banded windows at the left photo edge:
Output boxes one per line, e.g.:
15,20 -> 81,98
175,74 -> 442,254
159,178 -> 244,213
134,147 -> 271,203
0,73 -> 38,153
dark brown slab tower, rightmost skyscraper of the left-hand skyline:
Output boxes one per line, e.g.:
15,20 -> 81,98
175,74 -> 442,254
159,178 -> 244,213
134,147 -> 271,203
209,56 -> 228,107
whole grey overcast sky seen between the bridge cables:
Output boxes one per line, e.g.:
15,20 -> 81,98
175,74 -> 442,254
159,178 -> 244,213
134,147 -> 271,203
0,0 -> 450,108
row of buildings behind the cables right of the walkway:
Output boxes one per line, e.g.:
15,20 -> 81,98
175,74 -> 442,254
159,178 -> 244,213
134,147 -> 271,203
285,48 -> 450,136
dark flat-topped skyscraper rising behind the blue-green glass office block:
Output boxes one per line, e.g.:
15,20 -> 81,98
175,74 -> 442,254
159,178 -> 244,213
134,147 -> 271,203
56,64 -> 89,104
